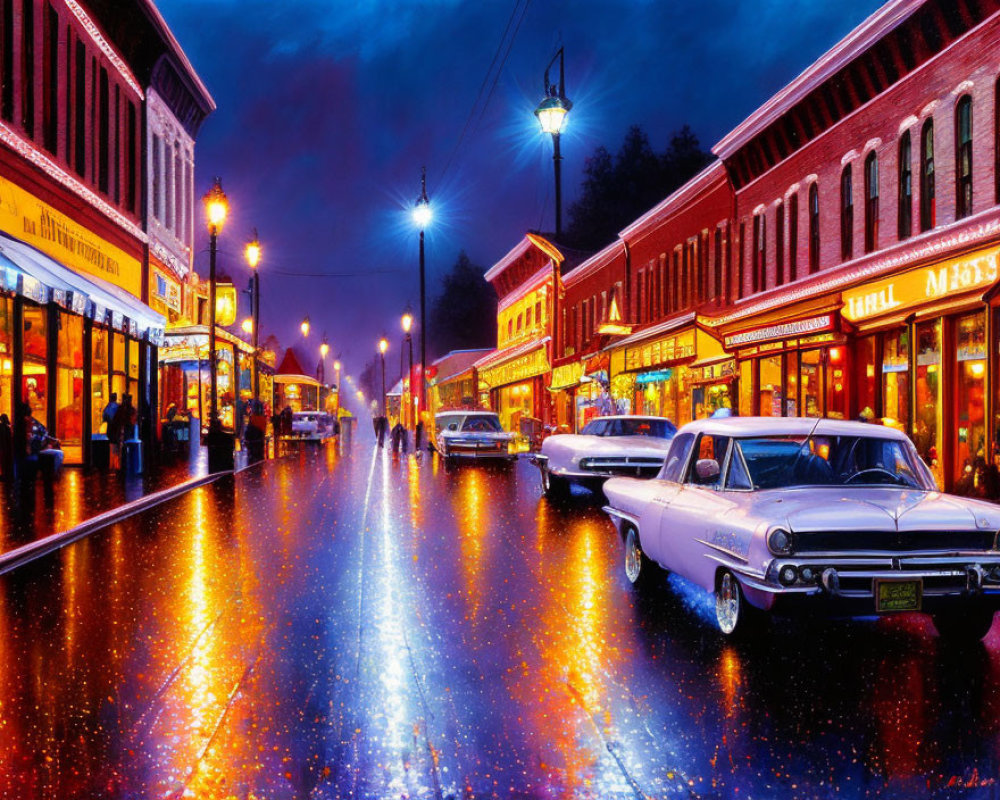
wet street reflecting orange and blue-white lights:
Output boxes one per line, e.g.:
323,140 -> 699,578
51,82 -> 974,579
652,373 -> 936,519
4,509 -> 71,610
0,441 -> 1000,800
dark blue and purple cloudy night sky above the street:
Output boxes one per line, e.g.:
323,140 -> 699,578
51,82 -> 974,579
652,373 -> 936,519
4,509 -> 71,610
158,0 -> 881,382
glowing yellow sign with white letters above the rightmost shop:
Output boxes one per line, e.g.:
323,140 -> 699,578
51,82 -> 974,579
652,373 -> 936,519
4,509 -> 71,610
841,248 -> 1000,322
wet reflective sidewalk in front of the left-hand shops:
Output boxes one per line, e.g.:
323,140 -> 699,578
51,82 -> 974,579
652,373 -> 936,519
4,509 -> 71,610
0,447 -> 247,554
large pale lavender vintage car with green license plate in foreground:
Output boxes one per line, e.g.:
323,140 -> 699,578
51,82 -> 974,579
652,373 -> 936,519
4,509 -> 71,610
604,417 -> 1000,641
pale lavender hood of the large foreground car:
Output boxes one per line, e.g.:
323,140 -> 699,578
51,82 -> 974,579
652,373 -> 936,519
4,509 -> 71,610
755,487 -> 1000,532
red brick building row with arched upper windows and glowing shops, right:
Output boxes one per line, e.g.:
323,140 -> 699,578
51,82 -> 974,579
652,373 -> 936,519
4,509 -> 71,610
488,0 -> 1000,491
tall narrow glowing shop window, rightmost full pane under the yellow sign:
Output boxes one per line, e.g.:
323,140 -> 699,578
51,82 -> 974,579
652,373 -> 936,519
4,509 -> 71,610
952,313 -> 989,494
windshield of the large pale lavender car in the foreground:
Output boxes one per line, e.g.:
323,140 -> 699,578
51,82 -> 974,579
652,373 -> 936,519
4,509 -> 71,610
734,436 -> 935,490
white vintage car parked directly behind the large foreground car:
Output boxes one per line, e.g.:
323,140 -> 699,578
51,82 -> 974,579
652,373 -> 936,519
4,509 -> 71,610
532,416 -> 677,497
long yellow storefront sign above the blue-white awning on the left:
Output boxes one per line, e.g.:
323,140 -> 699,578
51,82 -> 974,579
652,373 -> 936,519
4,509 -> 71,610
0,172 -> 142,297
